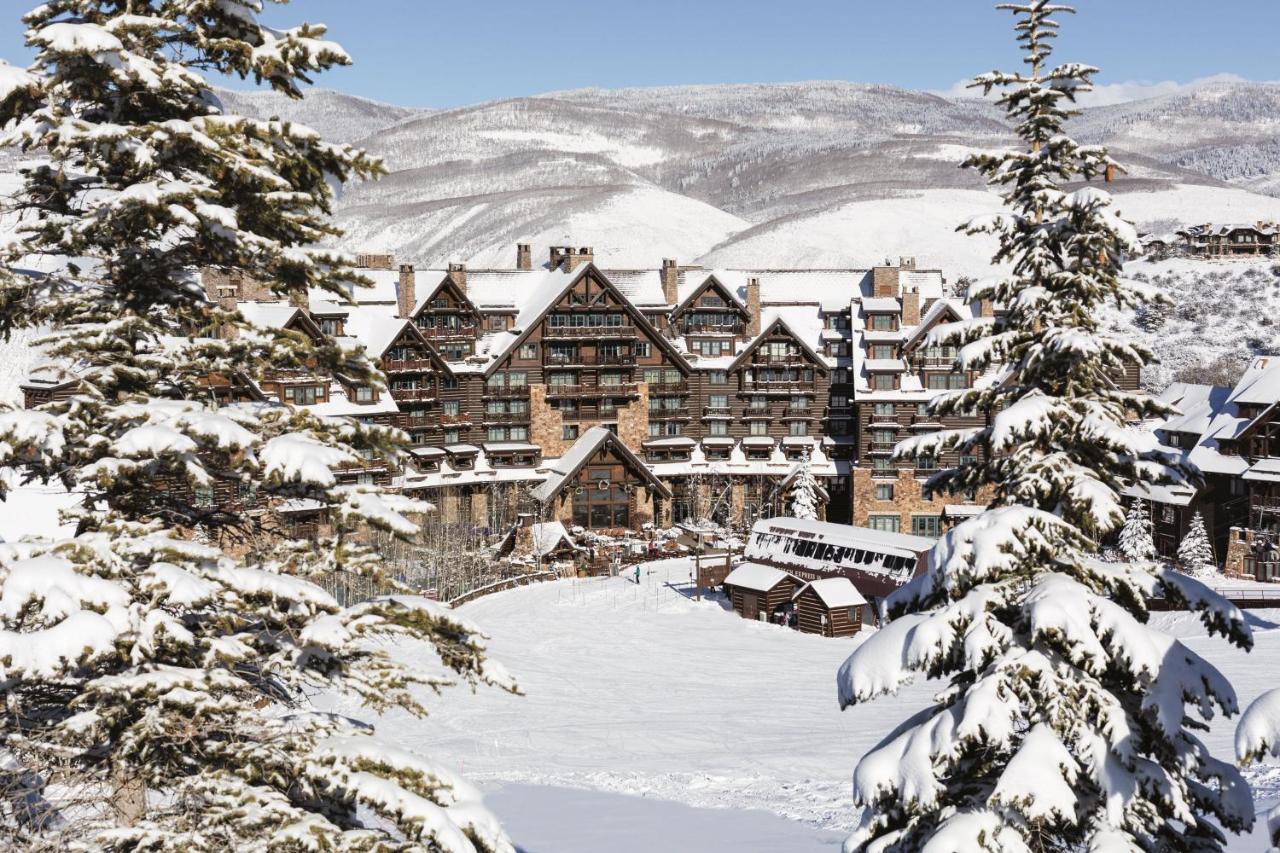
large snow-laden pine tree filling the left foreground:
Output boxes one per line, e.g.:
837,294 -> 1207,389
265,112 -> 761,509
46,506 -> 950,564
0,0 -> 513,850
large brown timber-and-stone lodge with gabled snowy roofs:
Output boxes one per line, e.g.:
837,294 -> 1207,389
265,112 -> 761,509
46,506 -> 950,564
24,245 -> 1049,537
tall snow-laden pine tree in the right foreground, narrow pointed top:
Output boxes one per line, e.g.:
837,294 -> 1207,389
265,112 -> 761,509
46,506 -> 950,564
838,0 -> 1253,852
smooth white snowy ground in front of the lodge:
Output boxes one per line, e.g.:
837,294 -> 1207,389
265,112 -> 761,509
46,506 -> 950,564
327,560 -> 1280,853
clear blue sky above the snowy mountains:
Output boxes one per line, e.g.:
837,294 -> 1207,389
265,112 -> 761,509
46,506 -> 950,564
0,0 -> 1280,106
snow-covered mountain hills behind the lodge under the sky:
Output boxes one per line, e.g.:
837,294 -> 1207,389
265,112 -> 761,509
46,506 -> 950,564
312,82 -> 1280,274
